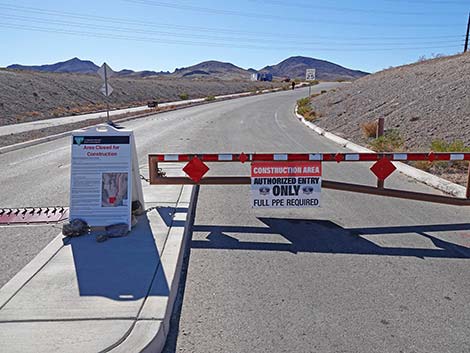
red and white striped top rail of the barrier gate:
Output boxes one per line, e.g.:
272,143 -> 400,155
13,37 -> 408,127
149,152 -> 470,163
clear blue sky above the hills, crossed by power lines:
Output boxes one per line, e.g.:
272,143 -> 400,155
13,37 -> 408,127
0,0 -> 470,72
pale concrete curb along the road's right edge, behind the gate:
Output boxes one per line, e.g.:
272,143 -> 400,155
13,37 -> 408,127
294,105 -> 466,198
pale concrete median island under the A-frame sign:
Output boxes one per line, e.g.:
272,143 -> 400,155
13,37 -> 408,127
0,176 -> 196,353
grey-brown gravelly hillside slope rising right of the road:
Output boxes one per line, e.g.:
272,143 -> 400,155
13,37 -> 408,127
312,53 -> 470,150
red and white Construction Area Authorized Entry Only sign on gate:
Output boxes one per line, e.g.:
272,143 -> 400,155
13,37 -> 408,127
251,162 -> 321,208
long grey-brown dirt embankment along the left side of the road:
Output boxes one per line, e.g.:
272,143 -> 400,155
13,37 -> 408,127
0,69 -> 281,125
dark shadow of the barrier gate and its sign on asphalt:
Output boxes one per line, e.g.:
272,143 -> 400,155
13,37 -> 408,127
191,218 -> 470,259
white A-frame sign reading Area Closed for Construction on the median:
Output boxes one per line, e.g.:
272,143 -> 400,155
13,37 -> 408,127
70,124 -> 143,230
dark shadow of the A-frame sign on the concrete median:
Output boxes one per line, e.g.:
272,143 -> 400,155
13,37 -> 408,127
66,212 -> 169,301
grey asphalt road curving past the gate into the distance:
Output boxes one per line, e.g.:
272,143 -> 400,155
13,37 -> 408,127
0,84 -> 470,353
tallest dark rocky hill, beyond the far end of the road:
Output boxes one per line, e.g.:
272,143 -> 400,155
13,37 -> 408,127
260,56 -> 367,81
